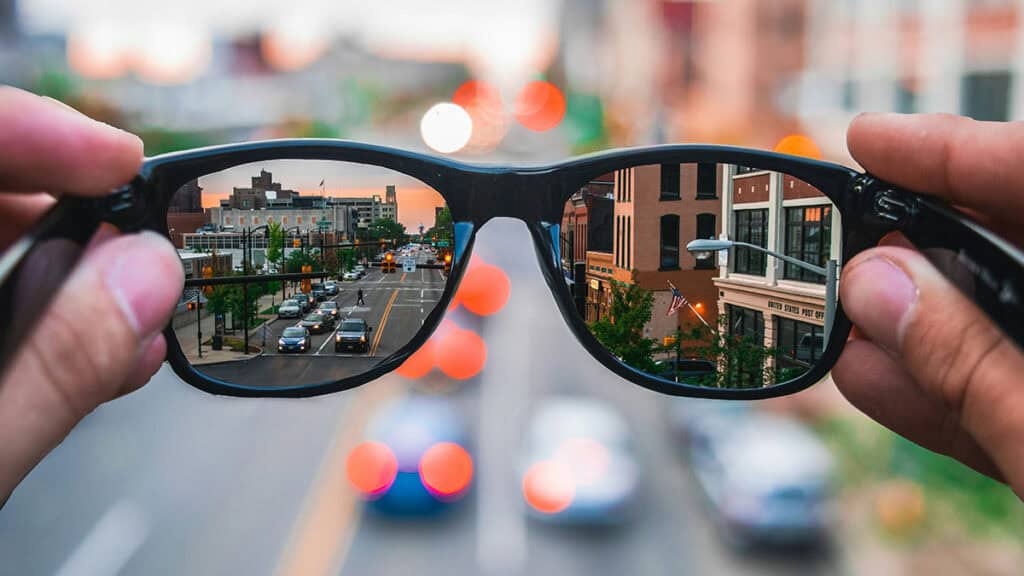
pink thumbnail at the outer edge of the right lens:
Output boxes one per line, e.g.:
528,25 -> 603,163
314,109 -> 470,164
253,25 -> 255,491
841,256 -> 918,352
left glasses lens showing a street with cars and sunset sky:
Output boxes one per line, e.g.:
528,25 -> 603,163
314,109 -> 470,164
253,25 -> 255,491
167,160 -> 453,388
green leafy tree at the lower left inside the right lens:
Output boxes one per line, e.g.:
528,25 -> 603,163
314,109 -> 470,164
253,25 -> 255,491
590,281 -> 658,372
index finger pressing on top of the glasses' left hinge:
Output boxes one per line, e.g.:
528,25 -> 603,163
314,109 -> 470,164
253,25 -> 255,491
0,86 -> 142,195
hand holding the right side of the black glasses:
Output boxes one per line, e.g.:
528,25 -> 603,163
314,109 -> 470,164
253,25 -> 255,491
833,115 -> 1024,498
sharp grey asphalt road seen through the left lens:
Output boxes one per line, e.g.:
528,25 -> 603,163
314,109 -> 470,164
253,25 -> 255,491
200,253 -> 445,386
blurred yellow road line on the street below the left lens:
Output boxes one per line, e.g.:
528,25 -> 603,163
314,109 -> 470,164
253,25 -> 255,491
273,378 -> 403,576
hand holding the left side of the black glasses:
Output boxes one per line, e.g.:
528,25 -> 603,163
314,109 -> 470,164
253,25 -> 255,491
0,86 -> 183,502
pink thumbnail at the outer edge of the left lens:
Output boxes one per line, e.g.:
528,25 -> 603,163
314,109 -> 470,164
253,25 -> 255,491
106,232 -> 181,337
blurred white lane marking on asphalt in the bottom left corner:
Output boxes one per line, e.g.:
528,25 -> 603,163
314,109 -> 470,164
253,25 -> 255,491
56,500 -> 150,576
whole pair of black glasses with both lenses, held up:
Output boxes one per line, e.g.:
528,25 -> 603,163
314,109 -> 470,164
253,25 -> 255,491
0,139 -> 1024,400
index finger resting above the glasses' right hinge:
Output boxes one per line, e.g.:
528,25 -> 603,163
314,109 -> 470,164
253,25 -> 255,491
847,114 -> 1024,215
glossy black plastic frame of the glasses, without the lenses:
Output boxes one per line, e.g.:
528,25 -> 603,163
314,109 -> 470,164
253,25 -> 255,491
0,139 -> 1024,400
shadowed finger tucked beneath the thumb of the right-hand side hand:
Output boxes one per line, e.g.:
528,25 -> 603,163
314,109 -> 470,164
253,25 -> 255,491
831,340 -> 1002,480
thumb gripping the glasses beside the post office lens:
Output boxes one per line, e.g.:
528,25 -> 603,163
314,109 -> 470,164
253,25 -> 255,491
840,241 -> 1024,494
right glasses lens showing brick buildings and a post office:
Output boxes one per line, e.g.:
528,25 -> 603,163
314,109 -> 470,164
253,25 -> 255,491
559,158 -> 842,388
